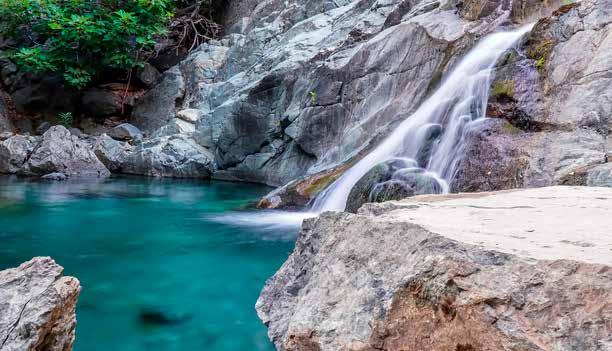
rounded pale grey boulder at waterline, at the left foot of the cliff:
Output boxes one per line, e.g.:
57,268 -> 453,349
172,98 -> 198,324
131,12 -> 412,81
122,135 -> 215,178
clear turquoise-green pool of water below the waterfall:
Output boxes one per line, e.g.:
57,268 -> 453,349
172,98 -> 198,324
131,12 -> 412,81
0,178 -> 295,351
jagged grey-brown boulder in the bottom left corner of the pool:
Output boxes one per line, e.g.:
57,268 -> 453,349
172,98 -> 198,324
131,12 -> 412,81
0,257 -> 81,351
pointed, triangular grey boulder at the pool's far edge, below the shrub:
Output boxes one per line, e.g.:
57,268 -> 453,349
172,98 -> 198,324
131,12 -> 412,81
23,126 -> 110,177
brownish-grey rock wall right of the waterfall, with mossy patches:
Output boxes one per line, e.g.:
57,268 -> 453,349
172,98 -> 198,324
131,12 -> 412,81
454,0 -> 612,191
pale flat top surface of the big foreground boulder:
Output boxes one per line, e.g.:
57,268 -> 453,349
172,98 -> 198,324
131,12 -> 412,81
361,186 -> 612,266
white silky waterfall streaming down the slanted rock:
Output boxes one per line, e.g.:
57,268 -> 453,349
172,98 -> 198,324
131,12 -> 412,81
312,25 -> 532,213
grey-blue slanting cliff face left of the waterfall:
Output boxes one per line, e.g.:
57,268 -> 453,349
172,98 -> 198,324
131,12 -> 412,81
130,0 -> 564,185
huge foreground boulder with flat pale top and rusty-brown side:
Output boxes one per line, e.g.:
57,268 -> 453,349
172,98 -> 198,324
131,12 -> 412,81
256,187 -> 612,351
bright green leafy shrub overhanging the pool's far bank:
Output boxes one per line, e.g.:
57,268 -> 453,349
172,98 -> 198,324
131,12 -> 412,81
0,0 -> 173,88
